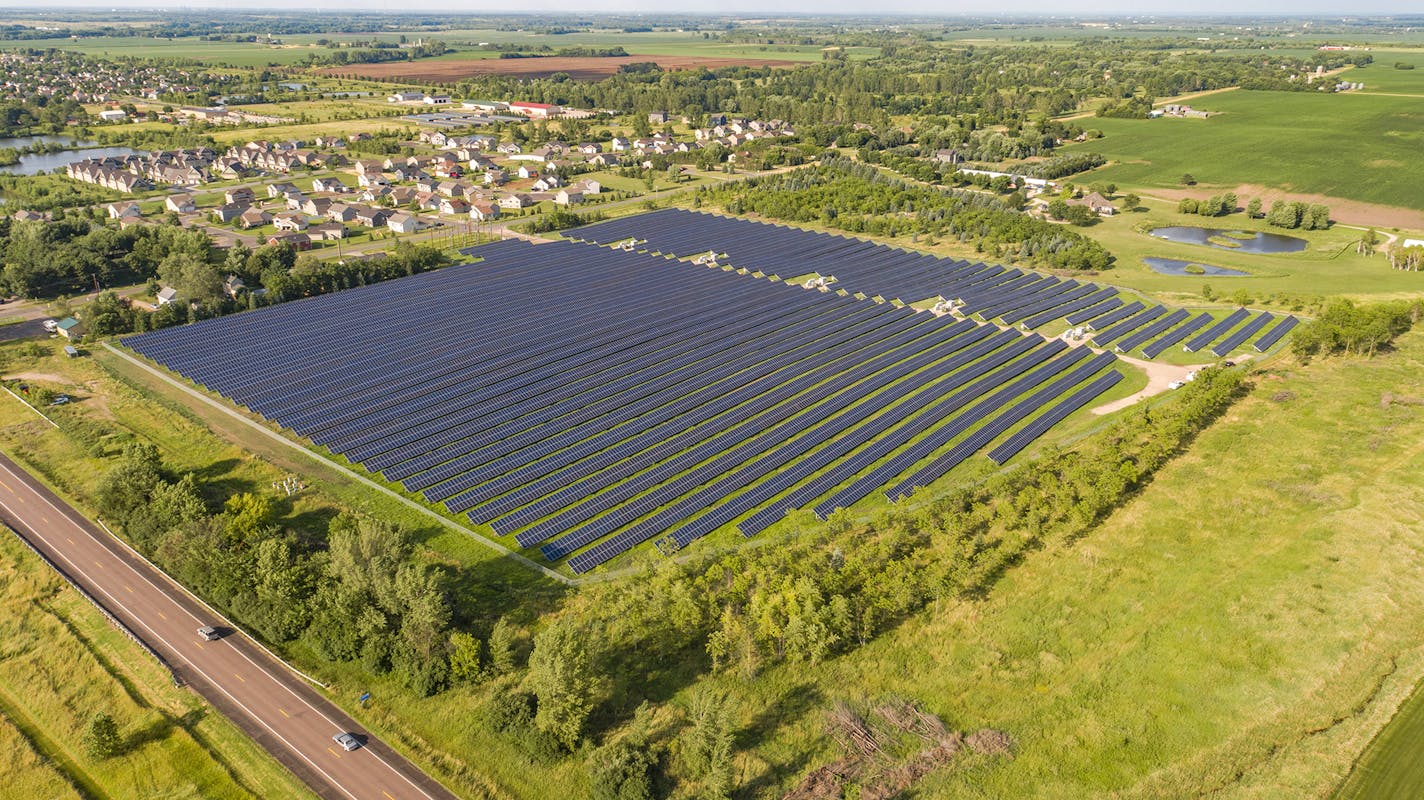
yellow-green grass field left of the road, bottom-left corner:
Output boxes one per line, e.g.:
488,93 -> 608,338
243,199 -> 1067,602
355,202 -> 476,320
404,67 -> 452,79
0,526 -> 309,799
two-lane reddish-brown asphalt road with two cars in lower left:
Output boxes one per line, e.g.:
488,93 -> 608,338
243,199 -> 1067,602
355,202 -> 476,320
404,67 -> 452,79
0,456 -> 454,800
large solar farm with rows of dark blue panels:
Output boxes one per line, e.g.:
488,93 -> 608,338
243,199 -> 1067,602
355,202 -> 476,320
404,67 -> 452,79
125,211 -> 1294,572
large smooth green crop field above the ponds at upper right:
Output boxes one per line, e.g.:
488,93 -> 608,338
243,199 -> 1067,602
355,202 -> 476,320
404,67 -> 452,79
1065,88 -> 1424,212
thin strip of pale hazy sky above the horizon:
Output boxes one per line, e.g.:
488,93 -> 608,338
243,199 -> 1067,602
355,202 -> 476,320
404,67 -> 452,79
0,0 -> 1424,19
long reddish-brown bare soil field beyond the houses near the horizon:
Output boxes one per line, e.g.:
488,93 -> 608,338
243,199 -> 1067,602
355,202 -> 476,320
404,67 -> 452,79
322,56 -> 806,83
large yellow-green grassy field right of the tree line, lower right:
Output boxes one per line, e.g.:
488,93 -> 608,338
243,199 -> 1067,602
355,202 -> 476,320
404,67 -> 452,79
719,325 -> 1424,799
